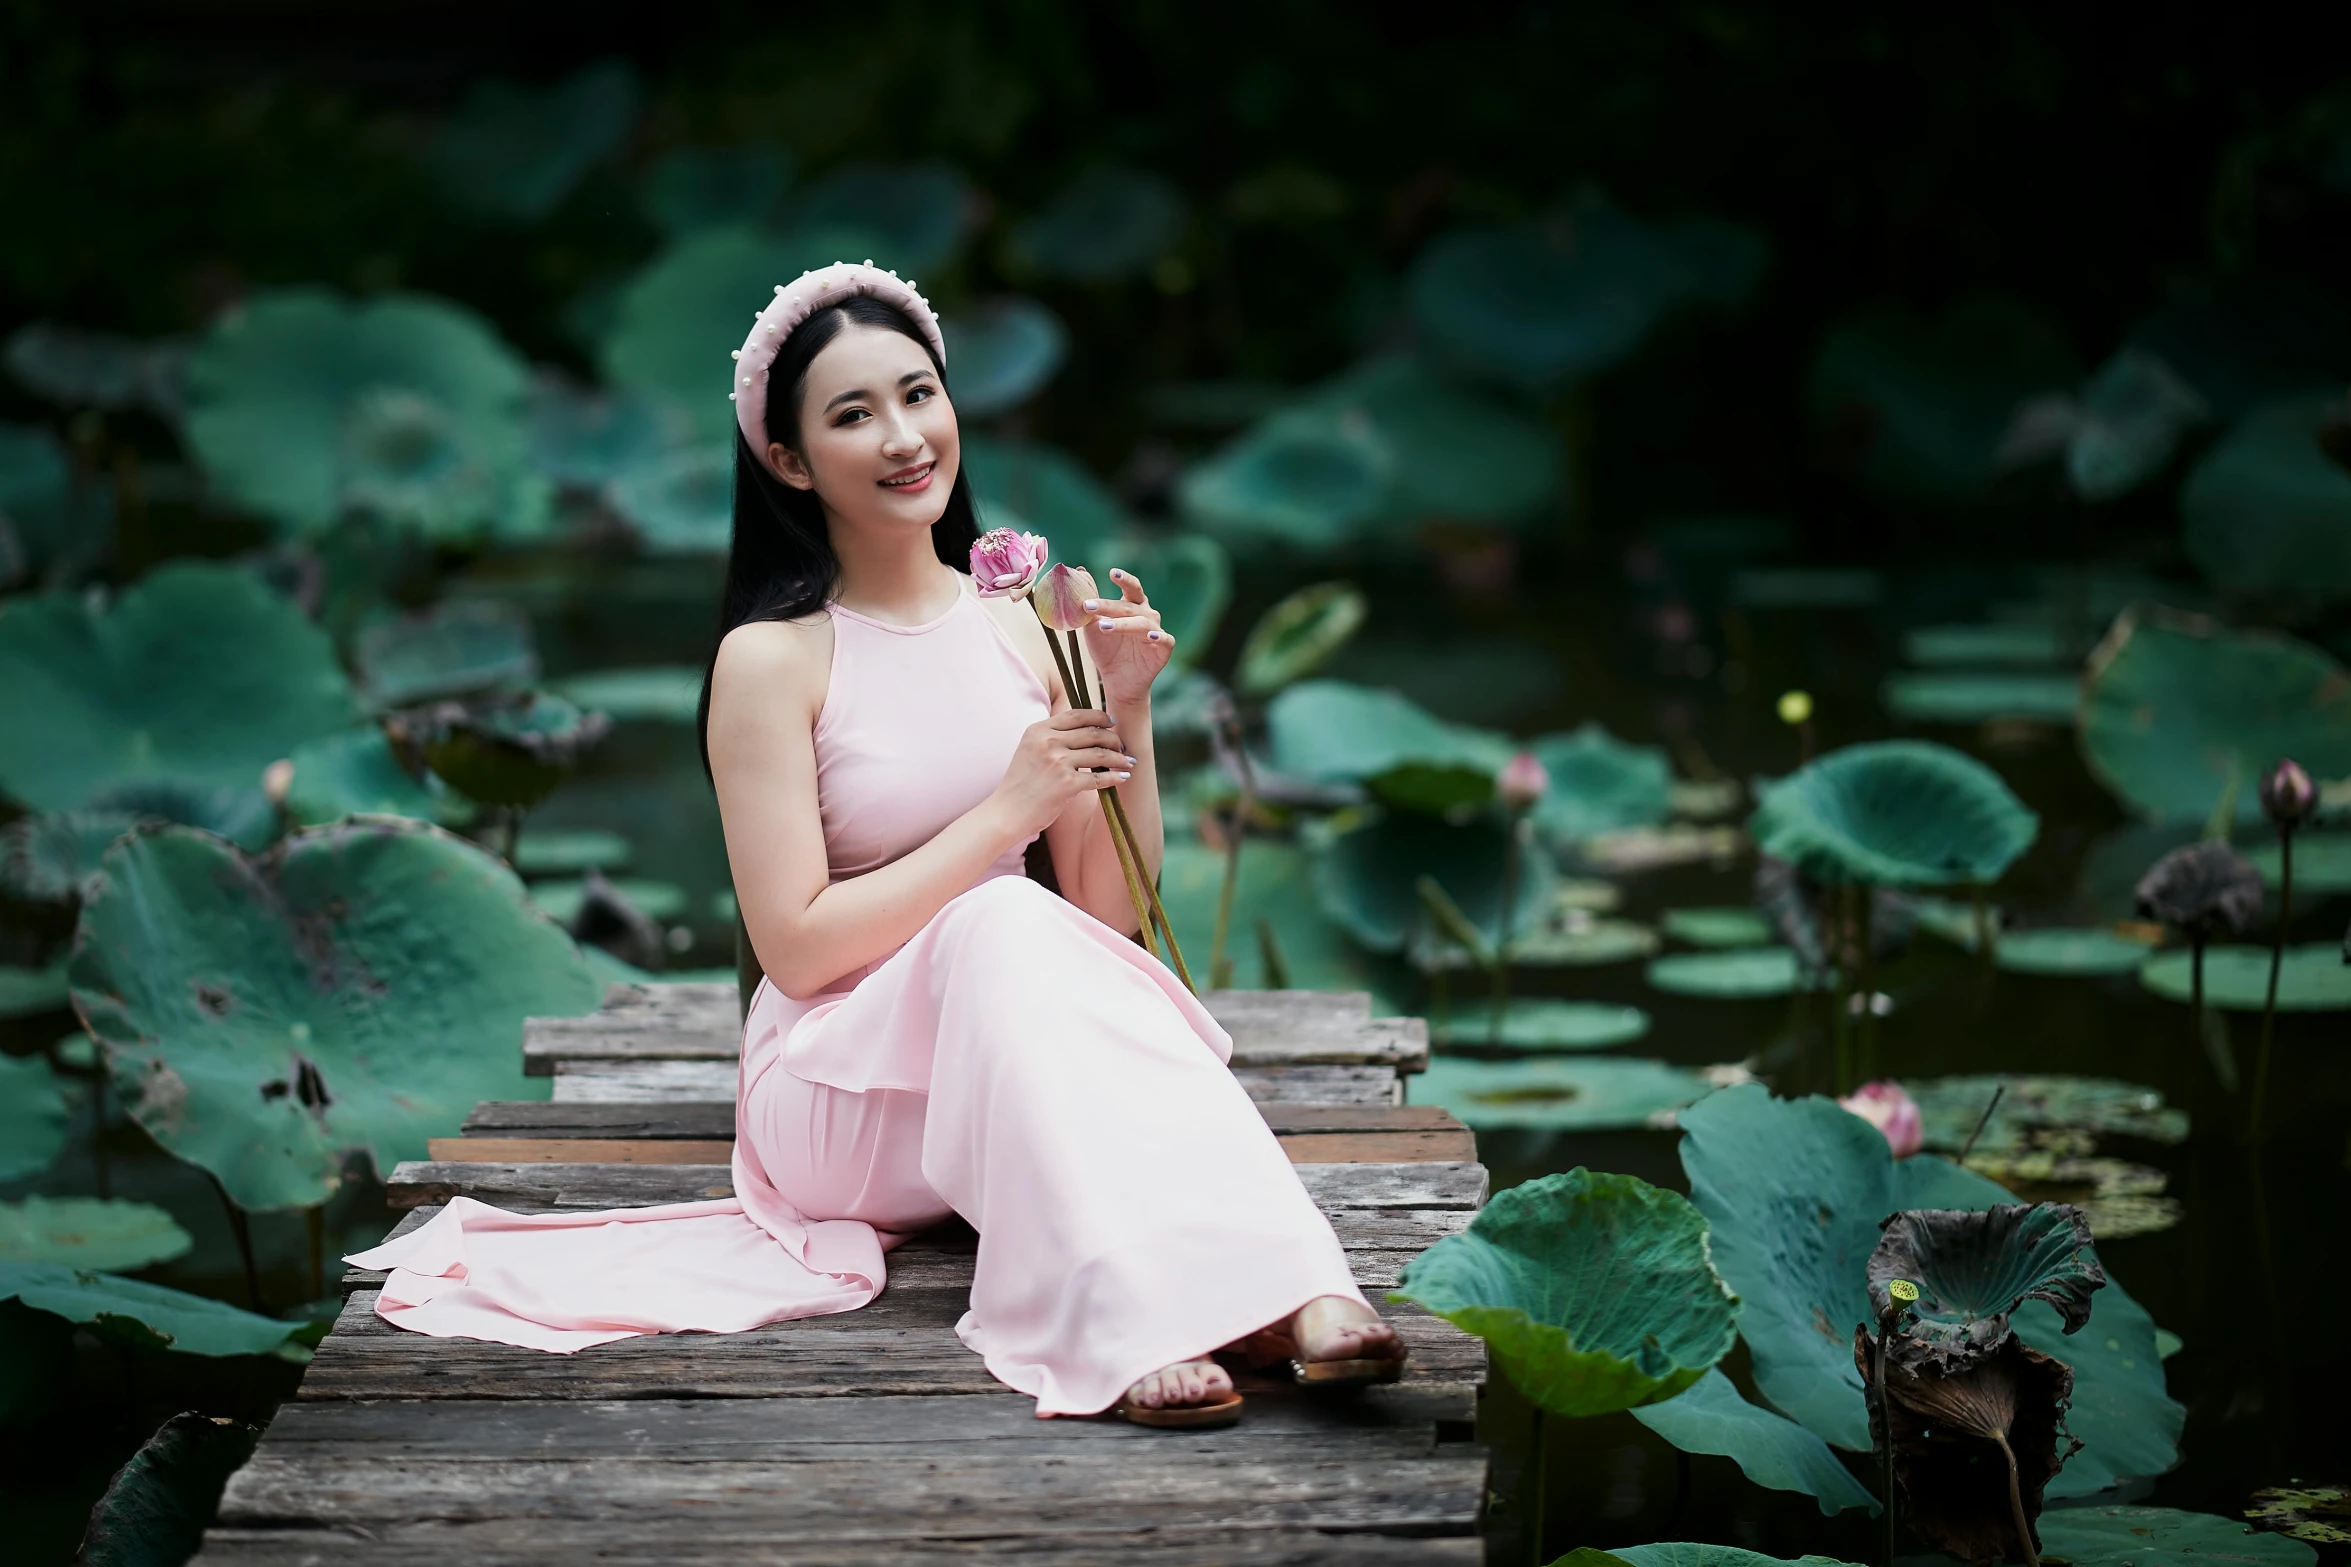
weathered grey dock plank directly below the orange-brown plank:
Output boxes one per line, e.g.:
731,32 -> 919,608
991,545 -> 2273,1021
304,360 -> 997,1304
386,1161 -> 1486,1210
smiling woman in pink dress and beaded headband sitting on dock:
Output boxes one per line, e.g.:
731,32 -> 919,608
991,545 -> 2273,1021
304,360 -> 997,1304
355,263 -> 1404,1424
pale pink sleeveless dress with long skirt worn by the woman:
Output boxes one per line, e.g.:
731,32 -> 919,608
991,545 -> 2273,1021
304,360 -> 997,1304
350,583 -> 1364,1414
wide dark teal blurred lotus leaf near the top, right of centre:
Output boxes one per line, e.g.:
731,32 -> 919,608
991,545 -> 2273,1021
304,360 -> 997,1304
1406,193 -> 1766,385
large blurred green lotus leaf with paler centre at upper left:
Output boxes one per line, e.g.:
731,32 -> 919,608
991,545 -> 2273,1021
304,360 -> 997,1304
186,287 -> 548,543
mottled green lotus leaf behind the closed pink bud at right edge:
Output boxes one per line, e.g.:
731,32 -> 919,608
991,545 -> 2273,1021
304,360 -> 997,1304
2081,608 -> 2351,825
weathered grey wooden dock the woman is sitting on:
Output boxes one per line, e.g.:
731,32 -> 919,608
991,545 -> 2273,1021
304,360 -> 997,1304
197,984 -> 1486,1567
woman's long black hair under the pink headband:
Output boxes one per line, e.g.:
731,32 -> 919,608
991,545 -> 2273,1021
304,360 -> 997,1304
694,294 -> 980,778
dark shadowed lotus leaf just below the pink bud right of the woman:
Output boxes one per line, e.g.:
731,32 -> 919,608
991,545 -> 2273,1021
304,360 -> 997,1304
1314,811 -> 1556,951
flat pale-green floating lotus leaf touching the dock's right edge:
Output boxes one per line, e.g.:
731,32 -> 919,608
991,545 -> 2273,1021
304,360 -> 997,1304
1406,1061 -> 1720,1132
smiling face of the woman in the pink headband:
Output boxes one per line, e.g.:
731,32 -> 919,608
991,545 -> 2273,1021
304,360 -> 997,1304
769,322 -> 962,540
